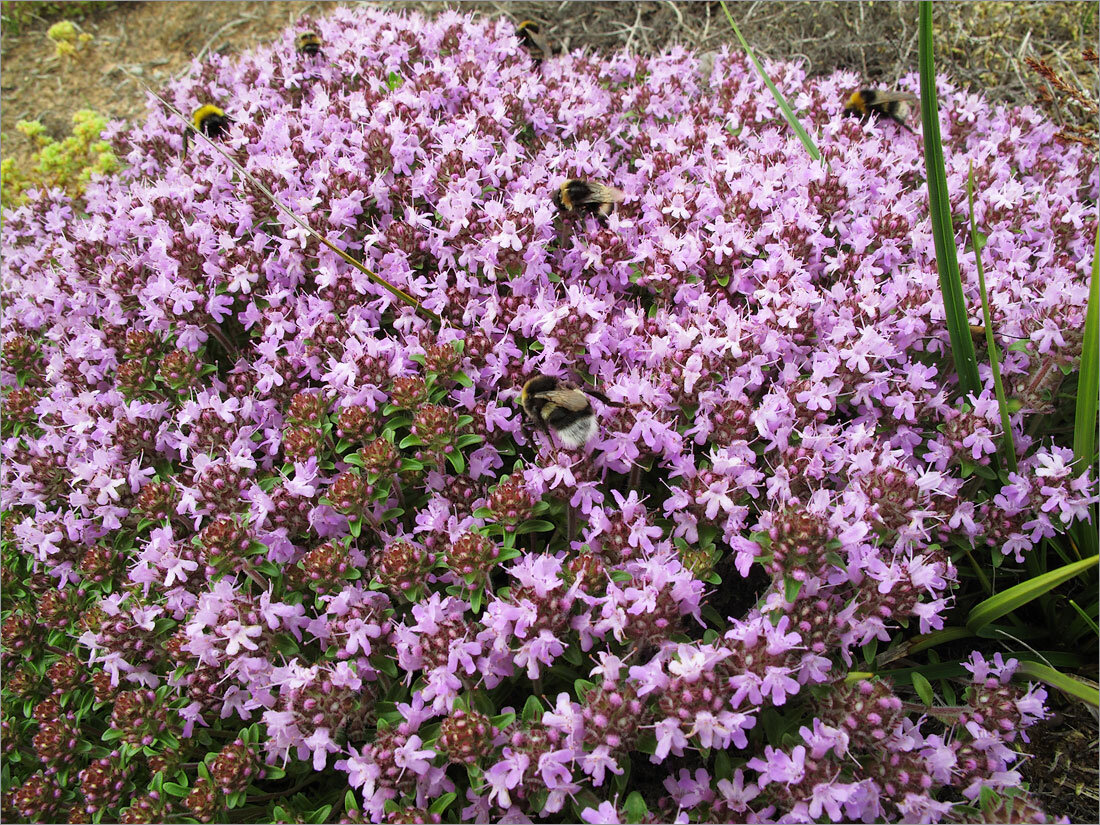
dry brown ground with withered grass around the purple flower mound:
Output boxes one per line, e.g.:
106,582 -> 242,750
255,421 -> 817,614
0,0 -> 1098,822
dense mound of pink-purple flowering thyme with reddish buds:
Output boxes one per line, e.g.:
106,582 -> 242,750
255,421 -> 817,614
2,9 -> 1098,823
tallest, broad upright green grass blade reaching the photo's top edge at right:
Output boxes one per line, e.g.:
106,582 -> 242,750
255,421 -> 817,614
919,0 -> 981,395
